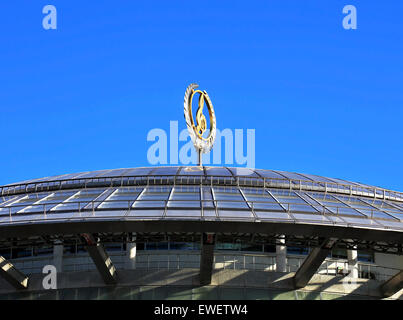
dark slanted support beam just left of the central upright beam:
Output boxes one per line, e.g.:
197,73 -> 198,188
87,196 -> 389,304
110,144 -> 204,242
81,233 -> 117,284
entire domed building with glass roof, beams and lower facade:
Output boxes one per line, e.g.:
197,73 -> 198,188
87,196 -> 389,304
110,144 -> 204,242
0,167 -> 403,299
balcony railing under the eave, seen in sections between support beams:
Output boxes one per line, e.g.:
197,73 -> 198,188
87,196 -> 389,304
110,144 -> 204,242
10,250 -> 400,281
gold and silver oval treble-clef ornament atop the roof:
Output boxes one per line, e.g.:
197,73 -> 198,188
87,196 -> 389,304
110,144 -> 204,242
184,83 -> 217,166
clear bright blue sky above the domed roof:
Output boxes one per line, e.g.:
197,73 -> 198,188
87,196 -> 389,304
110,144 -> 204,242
0,0 -> 403,191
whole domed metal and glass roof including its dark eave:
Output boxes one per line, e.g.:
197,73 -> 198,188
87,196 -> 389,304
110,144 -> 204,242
0,166 -> 403,255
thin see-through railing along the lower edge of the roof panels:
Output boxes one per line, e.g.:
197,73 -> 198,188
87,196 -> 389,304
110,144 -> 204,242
0,199 -> 403,229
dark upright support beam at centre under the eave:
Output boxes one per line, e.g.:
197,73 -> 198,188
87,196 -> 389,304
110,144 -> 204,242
199,233 -> 215,286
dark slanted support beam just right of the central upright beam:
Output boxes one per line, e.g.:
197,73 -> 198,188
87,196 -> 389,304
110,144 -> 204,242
293,238 -> 336,289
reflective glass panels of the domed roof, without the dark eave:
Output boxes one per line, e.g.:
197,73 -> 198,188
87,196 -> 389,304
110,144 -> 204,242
0,167 -> 403,229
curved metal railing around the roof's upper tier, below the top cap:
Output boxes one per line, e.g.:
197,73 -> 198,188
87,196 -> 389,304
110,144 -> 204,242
0,175 -> 403,202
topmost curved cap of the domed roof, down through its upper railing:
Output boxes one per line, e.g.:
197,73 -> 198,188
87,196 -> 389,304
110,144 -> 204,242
0,166 -> 403,202
